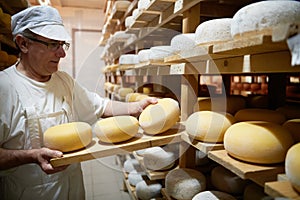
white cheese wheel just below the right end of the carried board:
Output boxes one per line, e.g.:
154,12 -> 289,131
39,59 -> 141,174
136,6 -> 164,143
143,147 -> 176,171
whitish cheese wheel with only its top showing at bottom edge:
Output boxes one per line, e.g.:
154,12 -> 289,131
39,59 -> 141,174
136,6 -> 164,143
192,191 -> 236,200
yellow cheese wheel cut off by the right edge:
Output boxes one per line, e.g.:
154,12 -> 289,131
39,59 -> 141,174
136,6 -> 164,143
285,143 -> 300,192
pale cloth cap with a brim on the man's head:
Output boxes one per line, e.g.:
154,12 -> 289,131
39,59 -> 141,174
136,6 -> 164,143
11,6 -> 71,41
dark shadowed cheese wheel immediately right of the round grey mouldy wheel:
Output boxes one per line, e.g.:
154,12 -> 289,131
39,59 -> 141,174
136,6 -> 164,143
211,166 -> 248,195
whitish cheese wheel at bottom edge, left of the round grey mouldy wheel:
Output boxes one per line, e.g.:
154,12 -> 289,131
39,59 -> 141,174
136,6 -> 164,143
135,181 -> 162,200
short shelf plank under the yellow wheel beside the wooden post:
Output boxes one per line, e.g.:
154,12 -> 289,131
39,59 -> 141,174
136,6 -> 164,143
181,132 -> 224,154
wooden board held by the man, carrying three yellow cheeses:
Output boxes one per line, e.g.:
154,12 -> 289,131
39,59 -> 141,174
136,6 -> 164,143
51,128 -> 182,167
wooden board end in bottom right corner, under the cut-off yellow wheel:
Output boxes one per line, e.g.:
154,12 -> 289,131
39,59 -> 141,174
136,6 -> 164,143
265,181 -> 300,200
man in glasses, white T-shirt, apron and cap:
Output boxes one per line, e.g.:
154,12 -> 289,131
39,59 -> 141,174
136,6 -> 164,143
0,6 -> 157,200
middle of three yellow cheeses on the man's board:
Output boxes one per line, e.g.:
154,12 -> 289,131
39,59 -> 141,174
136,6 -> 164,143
93,116 -> 139,143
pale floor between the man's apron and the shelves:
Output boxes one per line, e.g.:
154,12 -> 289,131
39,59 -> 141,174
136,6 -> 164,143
81,156 -> 131,200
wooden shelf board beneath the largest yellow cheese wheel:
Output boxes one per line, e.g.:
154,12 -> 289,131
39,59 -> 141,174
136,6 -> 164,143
208,150 -> 284,187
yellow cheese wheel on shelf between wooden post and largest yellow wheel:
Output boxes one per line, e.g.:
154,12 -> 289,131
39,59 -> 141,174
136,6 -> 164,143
185,111 -> 236,143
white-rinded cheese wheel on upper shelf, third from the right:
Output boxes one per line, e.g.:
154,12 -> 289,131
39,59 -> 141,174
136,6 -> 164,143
170,33 -> 196,51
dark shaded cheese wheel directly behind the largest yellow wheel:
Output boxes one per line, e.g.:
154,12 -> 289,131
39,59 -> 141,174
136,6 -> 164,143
234,108 -> 286,124
